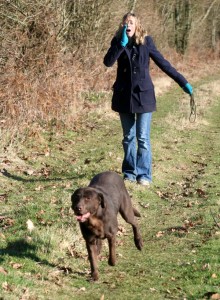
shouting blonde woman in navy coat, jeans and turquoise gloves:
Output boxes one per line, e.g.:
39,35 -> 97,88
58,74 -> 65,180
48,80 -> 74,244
104,13 -> 193,186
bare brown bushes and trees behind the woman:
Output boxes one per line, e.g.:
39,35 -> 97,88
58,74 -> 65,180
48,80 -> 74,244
0,0 -> 220,135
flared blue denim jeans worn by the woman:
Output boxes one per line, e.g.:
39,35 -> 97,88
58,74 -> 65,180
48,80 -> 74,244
119,113 -> 152,182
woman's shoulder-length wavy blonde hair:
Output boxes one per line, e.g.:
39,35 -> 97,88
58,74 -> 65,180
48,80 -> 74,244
116,12 -> 147,45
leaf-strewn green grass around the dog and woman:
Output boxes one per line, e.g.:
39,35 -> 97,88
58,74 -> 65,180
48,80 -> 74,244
0,73 -> 220,300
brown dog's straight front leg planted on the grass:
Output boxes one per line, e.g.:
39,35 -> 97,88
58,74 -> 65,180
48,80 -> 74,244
86,239 -> 99,281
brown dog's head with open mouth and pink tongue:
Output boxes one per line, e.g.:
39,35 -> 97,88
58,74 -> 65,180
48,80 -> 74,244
71,187 -> 105,222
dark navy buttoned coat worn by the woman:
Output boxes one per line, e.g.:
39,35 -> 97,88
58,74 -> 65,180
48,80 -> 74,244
104,36 -> 187,113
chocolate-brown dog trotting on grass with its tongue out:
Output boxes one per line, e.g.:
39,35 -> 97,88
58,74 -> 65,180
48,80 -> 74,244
71,172 -> 143,280
